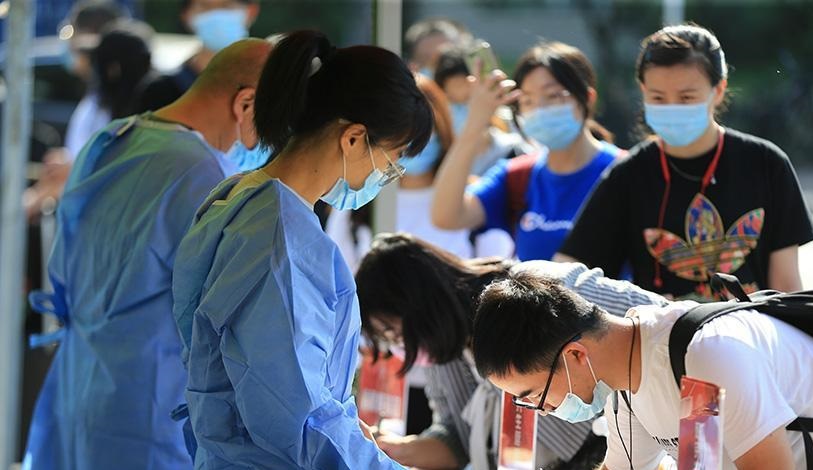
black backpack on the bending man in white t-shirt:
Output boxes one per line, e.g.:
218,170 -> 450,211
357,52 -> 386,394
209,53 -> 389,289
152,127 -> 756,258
669,273 -> 813,470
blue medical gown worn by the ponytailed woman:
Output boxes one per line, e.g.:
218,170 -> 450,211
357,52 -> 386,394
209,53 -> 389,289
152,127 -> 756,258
173,177 -> 402,470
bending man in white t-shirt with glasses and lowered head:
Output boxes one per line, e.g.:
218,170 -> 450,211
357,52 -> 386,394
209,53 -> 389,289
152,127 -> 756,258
473,272 -> 813,470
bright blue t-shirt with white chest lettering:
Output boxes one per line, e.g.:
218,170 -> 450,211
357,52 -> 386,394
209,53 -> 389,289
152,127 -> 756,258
467,142 -> 622,261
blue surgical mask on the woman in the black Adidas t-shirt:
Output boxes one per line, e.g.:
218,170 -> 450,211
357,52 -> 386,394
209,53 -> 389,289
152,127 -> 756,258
644,94 -> 714,147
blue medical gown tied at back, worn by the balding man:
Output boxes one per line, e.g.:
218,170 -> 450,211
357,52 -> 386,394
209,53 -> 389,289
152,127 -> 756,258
24,114 -> 233,470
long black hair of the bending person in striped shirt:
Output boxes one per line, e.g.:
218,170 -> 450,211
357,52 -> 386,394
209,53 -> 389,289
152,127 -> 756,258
356,234 -> 511,373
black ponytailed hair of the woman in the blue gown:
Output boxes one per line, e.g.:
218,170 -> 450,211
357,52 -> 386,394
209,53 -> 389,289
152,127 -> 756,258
254,31 -> 433,159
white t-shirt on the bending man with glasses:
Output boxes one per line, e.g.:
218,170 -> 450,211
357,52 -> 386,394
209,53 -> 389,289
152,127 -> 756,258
605,302 -> 813,470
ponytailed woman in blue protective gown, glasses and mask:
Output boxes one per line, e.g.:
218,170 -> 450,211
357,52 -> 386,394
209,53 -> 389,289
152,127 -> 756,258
173,31 -> 432,469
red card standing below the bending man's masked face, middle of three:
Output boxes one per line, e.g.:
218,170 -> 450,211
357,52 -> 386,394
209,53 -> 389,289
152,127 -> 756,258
498,393 -> 538,470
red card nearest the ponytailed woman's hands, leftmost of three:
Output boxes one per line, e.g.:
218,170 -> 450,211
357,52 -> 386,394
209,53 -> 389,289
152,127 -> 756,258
357,352 -> 405,426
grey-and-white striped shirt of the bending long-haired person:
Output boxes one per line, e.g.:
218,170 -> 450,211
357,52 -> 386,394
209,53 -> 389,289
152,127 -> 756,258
422,261 -> 668,466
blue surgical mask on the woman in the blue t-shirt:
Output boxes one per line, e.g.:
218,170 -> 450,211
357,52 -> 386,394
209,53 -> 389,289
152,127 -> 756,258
521,103 -> 584,150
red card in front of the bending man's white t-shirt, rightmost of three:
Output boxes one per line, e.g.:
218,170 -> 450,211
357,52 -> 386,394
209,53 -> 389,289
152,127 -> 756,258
678,376 -> 725,470
